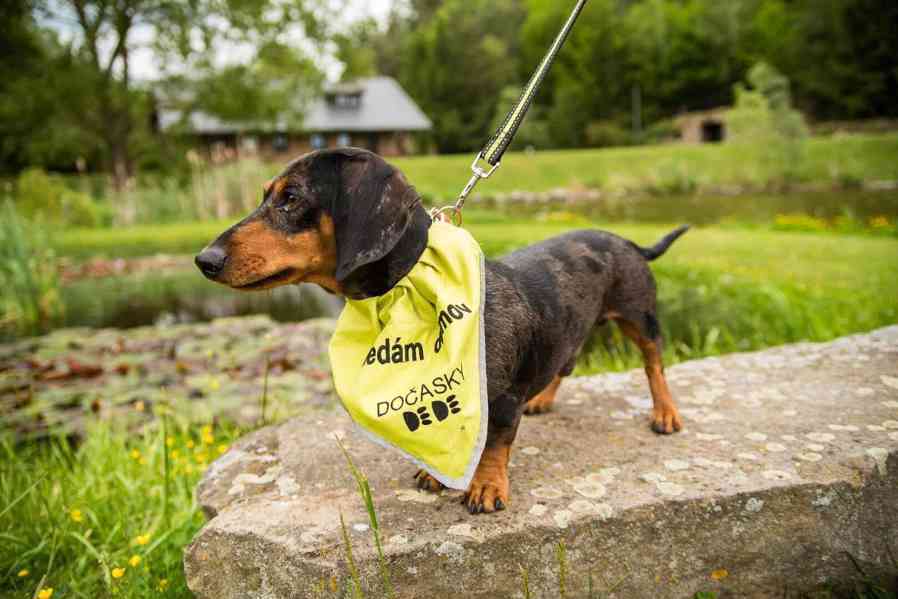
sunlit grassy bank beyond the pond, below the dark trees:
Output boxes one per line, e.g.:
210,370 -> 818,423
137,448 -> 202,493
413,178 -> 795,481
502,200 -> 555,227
391,134 -> 898,199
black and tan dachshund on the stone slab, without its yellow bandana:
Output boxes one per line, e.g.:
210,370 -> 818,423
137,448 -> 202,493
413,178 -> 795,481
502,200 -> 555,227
196,148 -> 686,514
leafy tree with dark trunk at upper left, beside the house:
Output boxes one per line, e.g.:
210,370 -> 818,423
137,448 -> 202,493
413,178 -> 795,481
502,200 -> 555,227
37,0 -> 321,189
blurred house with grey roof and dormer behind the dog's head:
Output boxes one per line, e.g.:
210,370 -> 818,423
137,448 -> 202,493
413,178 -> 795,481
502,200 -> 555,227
157,77 -> 432,157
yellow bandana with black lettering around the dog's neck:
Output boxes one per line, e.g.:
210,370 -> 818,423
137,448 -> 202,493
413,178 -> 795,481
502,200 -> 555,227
330,222 -> 487,489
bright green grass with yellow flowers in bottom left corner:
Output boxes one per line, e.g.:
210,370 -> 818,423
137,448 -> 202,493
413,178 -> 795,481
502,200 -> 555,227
0,422 -> 239,599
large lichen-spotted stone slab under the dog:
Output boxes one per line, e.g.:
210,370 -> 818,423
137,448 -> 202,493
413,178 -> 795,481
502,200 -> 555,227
184,327 -> 898,599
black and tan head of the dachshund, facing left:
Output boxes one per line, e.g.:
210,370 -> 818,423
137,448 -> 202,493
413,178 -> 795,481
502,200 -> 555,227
196,148 -> 430,299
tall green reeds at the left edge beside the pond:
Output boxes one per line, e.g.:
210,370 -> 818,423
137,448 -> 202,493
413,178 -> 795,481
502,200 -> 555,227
0,201 -> 63,336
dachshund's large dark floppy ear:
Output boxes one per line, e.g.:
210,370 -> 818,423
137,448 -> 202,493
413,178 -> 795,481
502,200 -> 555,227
316,148 -> 430,299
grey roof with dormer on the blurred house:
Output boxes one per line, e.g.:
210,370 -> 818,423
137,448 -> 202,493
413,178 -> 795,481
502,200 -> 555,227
159,77 -> 432,135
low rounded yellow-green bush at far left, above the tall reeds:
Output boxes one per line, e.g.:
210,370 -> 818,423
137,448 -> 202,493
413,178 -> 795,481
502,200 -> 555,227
16,168 -> 111,227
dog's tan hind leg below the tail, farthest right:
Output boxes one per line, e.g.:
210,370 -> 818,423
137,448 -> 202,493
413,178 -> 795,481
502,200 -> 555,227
615,312 -> 683,435
